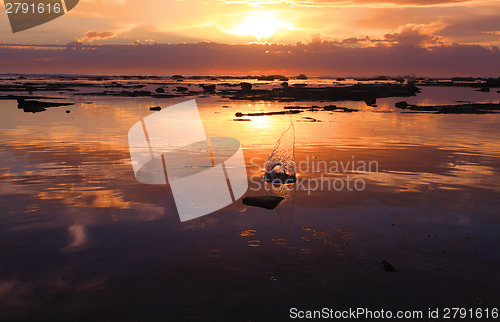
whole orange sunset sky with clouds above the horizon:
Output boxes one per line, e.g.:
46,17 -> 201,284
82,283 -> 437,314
0,0 -> 500,77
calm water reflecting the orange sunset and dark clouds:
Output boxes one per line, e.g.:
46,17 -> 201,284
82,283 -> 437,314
0,77 -> 500,321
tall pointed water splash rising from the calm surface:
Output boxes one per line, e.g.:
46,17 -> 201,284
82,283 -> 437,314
264,115 -> 297,184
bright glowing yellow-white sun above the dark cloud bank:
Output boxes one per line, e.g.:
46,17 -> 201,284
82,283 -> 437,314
228,12 -> 295,41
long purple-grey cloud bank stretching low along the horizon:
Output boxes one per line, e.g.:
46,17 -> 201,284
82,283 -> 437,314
0,41 -> 500,77
